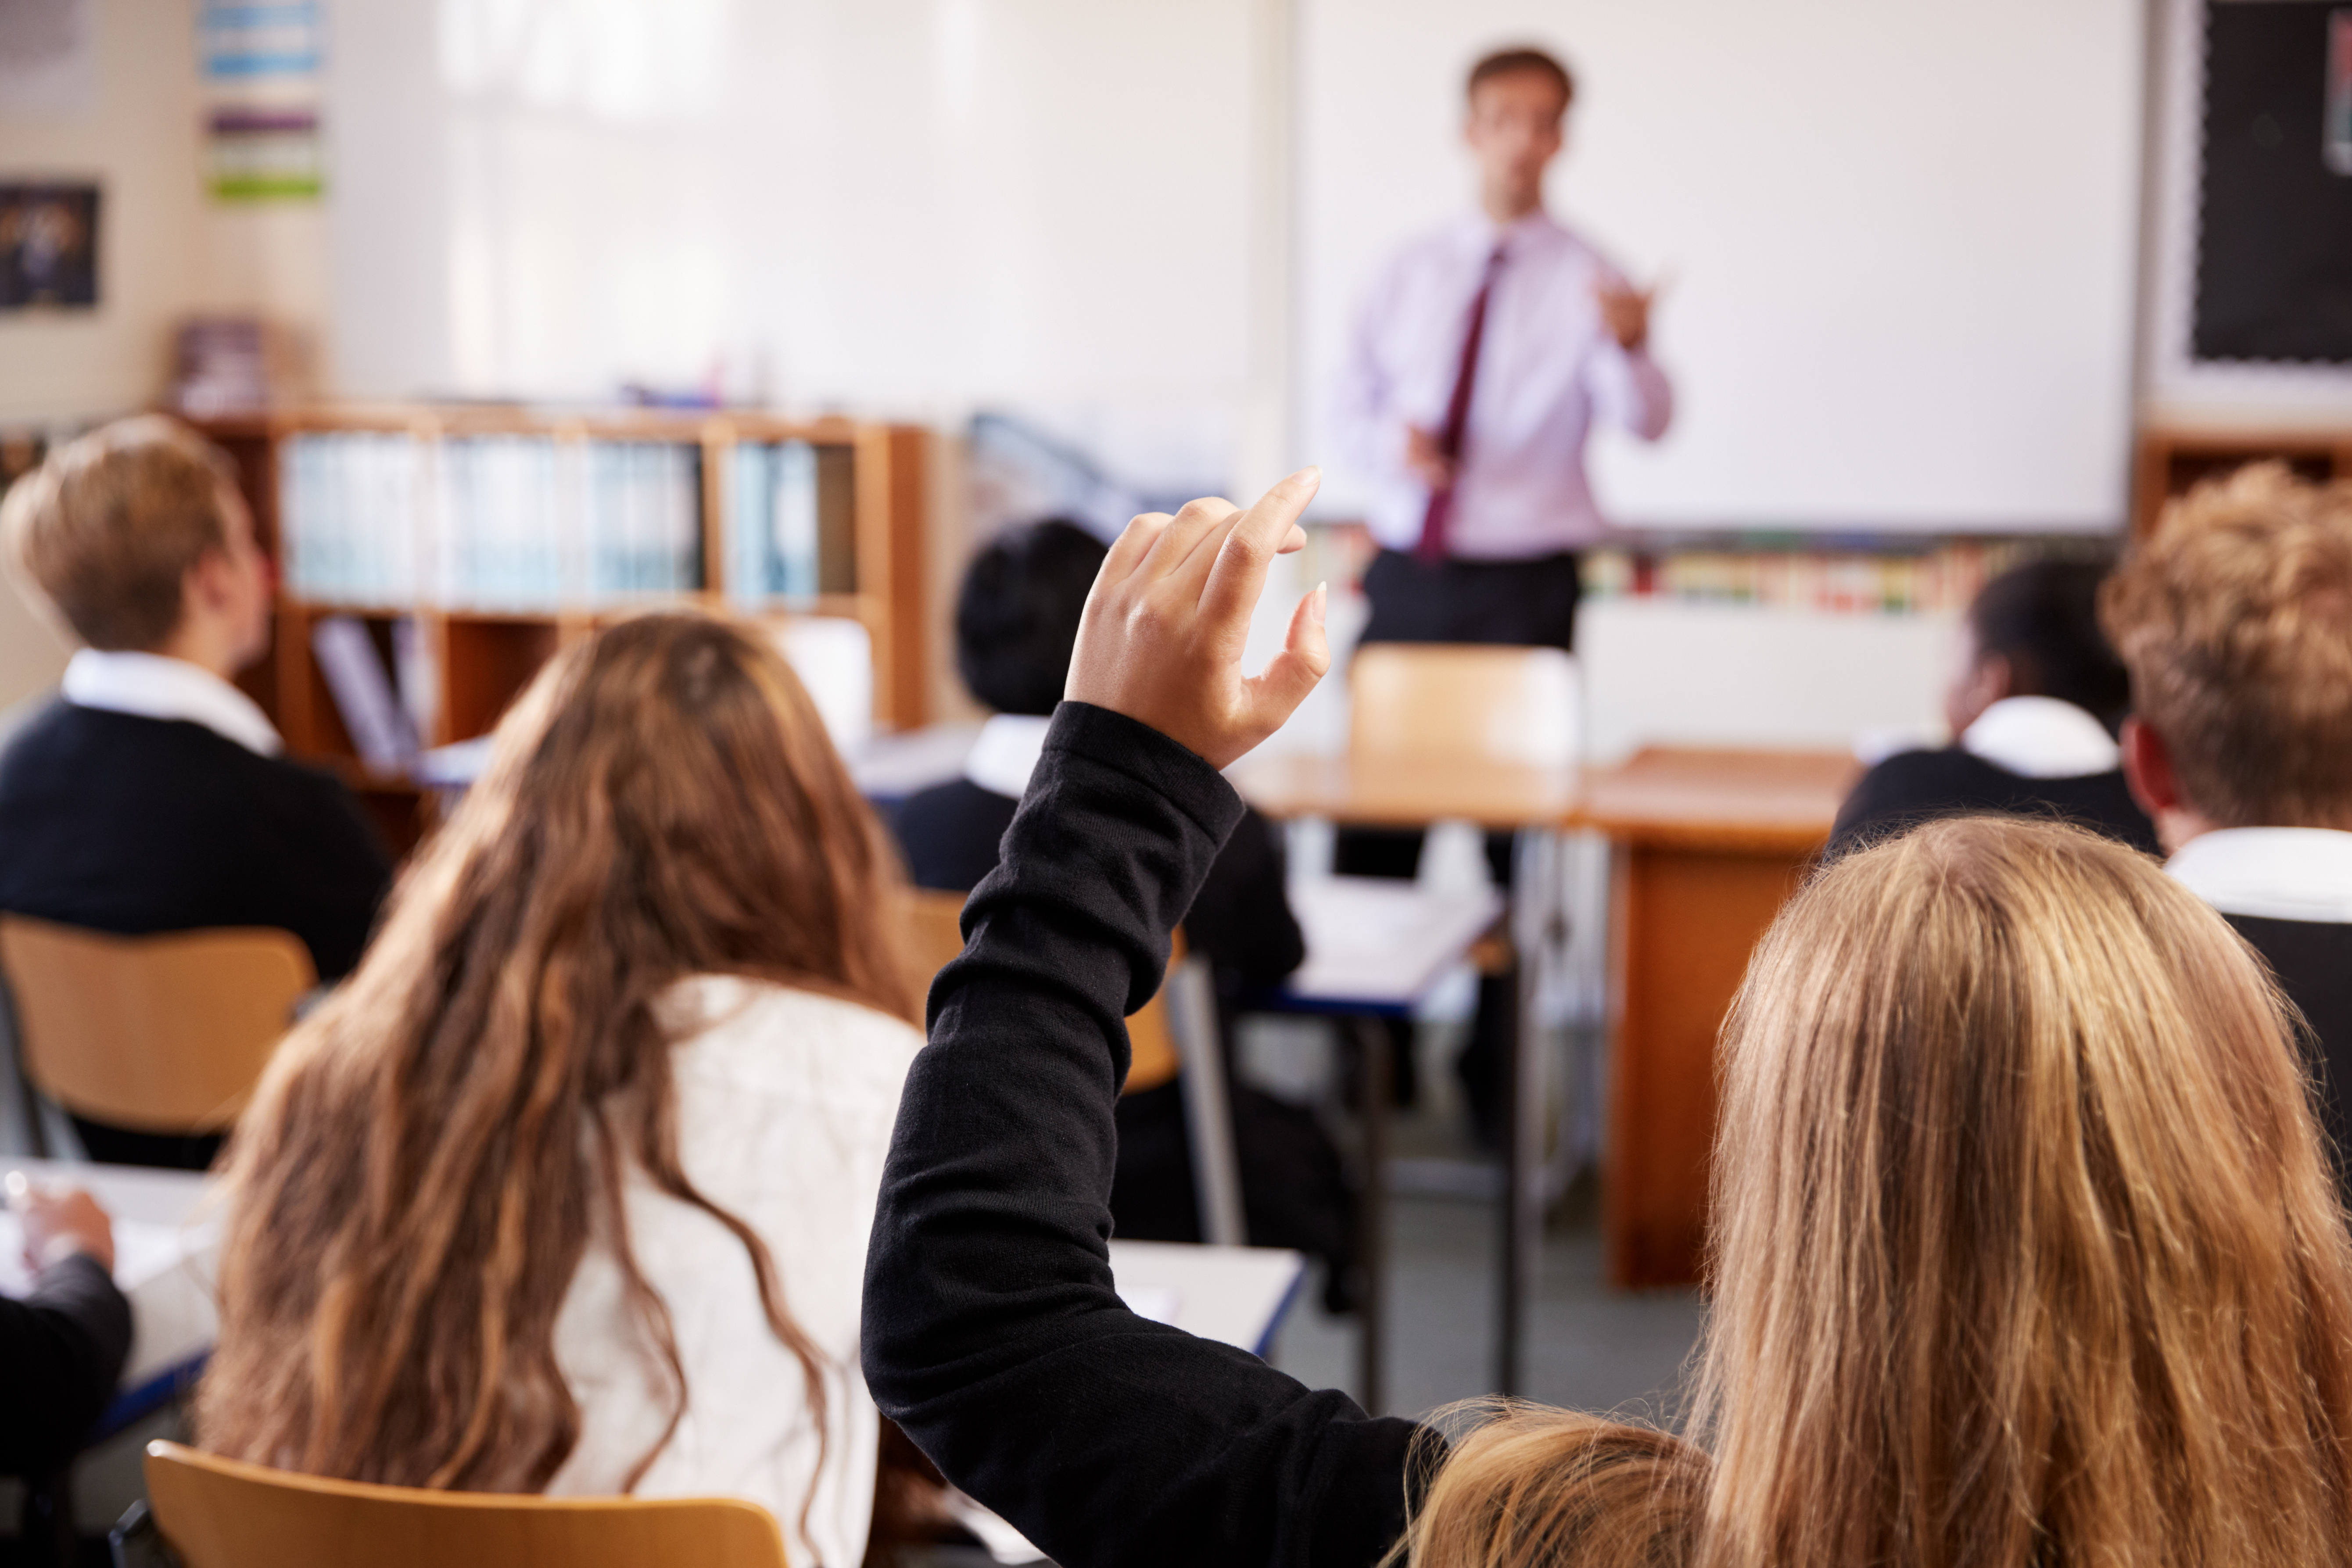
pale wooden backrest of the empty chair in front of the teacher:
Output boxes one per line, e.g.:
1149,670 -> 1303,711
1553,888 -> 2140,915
1348,642 -> 1583,766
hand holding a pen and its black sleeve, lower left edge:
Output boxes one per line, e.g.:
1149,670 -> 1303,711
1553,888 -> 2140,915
0,1185 -> 132,1476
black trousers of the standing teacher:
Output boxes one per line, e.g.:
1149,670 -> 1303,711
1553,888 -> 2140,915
1331,550 -> 1583,1147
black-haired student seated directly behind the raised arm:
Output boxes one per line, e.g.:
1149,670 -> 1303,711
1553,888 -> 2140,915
894,517 -> 1355,1307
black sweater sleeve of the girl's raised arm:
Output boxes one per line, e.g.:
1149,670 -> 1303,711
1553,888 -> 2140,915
863,703 -> 1418,1568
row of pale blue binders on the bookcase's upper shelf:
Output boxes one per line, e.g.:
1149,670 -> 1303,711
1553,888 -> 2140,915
277,430 -> 856,611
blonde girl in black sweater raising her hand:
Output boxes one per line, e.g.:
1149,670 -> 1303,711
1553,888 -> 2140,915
863,473 -> 2352,1568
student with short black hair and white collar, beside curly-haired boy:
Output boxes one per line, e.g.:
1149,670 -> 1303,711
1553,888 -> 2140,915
1830,562 -> 2157,853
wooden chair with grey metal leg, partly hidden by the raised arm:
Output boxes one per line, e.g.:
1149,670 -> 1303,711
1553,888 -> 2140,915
908,888 -> 1249,1246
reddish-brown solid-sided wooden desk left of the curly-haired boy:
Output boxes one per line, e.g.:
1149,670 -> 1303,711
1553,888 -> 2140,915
1569,748 -> 1858,1288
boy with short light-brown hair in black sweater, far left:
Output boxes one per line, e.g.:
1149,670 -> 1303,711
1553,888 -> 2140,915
0,416 -> 391,1168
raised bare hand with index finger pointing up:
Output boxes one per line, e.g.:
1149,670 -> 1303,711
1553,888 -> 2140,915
1063,468 -> 1331,766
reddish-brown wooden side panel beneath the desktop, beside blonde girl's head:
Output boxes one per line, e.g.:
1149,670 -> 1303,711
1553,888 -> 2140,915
1602,844 -> 1809,1288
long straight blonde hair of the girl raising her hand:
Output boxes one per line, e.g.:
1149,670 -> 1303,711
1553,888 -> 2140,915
1413,818 -> 2352,1568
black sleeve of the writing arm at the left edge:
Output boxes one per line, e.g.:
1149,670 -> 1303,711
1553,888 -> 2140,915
0,1255 -> 132,1476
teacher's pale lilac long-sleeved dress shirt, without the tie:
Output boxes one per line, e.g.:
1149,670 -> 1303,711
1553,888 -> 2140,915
1338,211 -> 1674,559
